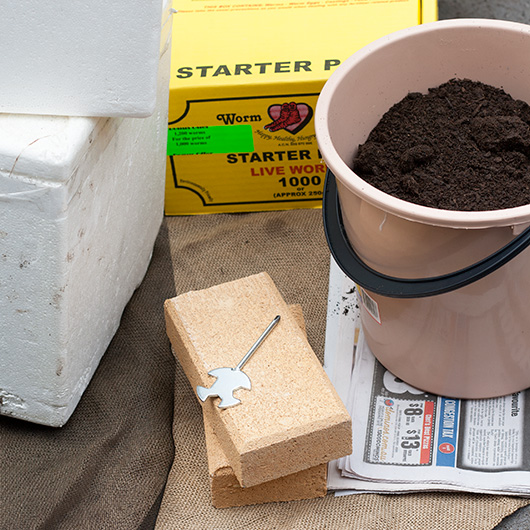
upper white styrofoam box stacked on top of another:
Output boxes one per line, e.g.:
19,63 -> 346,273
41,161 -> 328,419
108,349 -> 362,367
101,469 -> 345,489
0,0 -> 170,117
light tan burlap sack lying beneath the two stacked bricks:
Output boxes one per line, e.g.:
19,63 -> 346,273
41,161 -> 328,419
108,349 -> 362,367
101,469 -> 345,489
156,210 -> 529,530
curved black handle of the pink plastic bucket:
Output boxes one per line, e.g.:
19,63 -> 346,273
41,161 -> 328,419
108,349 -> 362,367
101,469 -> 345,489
322,169 -> 530,298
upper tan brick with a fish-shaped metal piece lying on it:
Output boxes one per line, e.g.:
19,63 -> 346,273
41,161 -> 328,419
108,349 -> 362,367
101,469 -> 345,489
165,273 -> 352,488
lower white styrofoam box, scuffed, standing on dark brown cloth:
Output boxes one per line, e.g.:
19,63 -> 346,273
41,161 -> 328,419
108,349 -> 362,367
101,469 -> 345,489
0,24 -> 170,426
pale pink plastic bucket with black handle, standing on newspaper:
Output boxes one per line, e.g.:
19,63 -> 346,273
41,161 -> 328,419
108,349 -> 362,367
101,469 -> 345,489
315,19 -> 530,398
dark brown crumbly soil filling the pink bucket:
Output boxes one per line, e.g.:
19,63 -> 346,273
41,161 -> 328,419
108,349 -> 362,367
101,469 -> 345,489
353,79 -> 530,211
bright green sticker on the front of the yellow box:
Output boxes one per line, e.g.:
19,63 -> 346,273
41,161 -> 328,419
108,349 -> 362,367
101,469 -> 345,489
167,125 -> 254,156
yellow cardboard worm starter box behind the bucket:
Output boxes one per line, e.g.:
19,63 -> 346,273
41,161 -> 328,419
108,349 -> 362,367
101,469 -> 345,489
166,0 -> 437,215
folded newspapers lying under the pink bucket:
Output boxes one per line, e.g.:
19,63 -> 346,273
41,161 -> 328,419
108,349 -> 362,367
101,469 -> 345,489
324,260 -> 530,496
